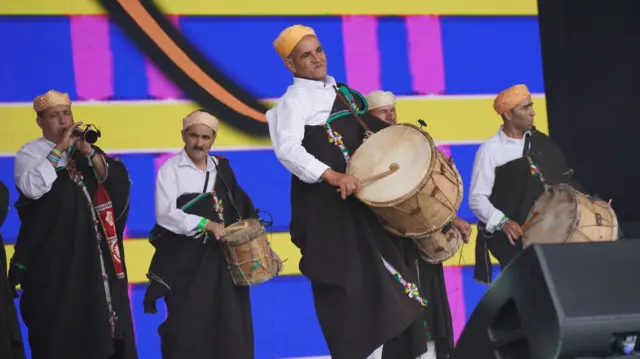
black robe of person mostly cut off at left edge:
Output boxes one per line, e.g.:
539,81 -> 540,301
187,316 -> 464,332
0,182 -> 26,359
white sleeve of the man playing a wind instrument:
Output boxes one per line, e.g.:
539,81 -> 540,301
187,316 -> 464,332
13,148 -> 58,200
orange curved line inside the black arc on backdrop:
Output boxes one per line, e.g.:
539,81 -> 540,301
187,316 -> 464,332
117,0 -> 267,123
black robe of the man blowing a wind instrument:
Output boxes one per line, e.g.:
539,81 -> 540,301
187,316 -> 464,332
9,147 -> 137,359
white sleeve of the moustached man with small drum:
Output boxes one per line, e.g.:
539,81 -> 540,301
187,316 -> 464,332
156,165 -> 202,236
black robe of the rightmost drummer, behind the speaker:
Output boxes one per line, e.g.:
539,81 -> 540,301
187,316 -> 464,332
474,127 -> 580,283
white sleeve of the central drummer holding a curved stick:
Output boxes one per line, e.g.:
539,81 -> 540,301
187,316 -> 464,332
267,98 -> 329,183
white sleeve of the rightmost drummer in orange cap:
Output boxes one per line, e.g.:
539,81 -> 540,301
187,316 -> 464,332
469,146 -> 504,233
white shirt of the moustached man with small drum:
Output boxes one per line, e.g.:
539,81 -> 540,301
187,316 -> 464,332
156,149 -> 218,236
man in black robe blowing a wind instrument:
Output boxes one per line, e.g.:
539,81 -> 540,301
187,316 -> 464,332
9,90 -> 137,359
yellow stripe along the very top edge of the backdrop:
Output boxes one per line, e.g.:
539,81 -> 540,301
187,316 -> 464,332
0,0 -> 538,16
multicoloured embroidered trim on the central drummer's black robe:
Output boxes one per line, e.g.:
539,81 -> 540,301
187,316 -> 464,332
325,93 -> 432,340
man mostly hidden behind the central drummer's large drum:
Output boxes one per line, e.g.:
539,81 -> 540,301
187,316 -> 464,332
366,90 -> 471,358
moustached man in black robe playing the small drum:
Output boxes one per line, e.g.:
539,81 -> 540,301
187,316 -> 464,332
144,110 -> 268,359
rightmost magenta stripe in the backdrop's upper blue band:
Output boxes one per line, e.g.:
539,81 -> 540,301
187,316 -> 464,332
405,15 -> 444,95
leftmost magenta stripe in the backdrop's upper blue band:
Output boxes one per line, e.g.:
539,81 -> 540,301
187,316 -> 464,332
71,15 -> 113,100
